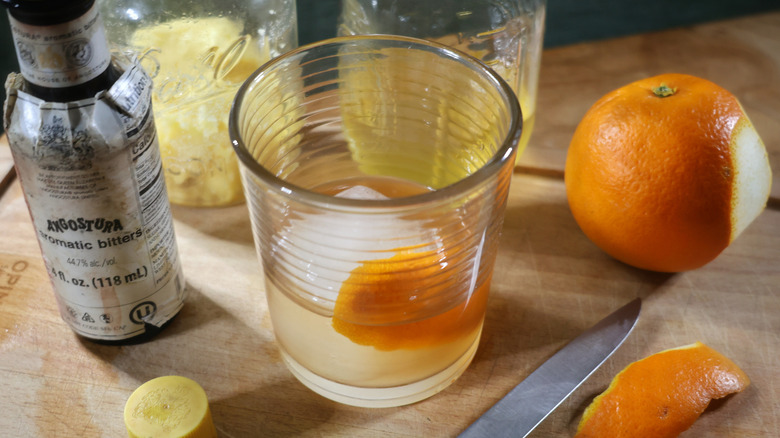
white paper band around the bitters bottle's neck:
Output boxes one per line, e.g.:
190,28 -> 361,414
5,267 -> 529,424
8,5 -> 111,88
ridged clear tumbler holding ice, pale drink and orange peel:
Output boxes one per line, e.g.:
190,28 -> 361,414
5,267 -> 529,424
230,36 -> 522,405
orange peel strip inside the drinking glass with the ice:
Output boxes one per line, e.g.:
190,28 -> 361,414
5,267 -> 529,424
332,251 -> 490,351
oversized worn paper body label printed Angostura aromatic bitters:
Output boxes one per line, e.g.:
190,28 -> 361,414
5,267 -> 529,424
8,63 -> 185,340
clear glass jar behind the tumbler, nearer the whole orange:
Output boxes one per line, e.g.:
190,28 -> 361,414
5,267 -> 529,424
338,0 -> 547,163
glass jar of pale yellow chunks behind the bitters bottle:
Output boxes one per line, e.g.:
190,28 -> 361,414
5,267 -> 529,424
99,0 -> 298,207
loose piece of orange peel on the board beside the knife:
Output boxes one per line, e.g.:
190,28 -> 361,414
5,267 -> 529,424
575,342 -> 750,438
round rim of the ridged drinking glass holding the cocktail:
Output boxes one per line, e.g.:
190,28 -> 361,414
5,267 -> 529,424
228,34 -> 523,211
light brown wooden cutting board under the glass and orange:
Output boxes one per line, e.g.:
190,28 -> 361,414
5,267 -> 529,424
0,13 -> 780,437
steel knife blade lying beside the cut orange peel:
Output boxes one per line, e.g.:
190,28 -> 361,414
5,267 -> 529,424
458,298 -> 642,438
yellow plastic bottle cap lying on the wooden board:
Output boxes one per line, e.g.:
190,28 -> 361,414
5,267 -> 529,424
125,376 -> 217,438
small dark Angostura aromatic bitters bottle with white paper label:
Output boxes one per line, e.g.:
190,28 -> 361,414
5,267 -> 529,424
1,0 -> 185,343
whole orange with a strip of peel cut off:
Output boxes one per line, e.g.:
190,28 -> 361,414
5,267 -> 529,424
565,74 -> 772,272
